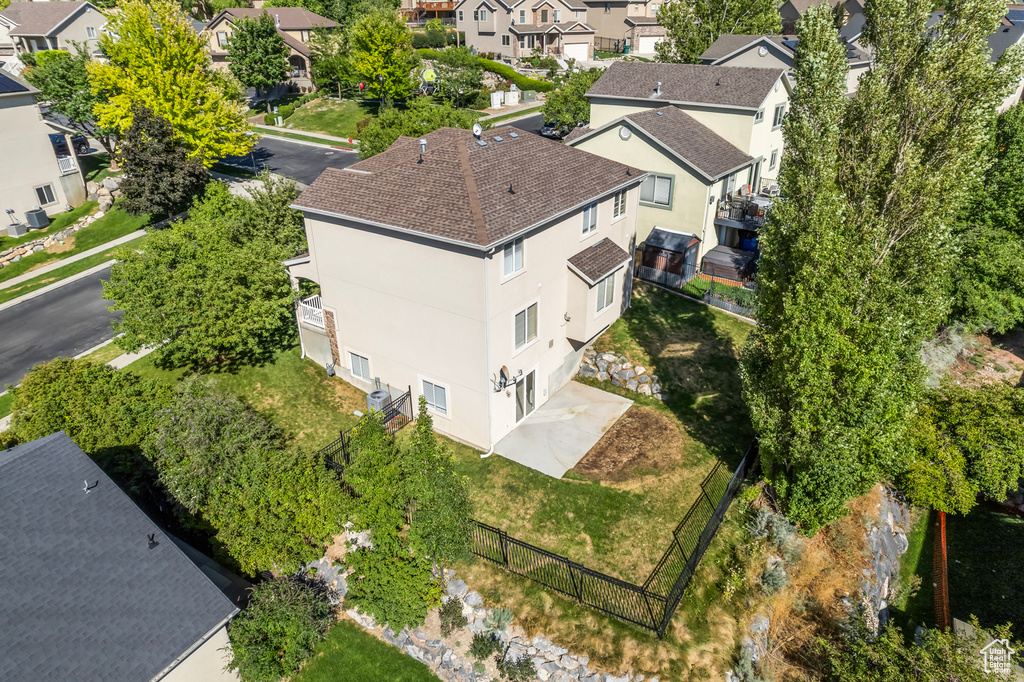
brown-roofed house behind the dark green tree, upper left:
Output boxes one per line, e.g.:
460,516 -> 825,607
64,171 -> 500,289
206,7 -> 338,92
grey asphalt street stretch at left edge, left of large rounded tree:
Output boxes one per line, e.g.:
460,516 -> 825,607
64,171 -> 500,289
0,268 -> 121,391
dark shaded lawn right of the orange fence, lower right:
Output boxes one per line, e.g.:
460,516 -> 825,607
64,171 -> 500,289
946,506 -> 1024,640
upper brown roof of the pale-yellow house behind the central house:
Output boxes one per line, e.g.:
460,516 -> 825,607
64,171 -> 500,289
587,61 -> 783,110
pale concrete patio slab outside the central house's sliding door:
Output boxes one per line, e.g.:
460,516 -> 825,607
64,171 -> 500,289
495,381 -> 633,478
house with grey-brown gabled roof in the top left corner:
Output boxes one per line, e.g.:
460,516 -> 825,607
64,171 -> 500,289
0,2 -> 106,54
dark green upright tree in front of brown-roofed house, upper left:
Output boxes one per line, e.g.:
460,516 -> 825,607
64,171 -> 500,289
227,11 -> 289,114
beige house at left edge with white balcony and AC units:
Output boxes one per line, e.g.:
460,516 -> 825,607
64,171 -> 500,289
0,72 -> 85,227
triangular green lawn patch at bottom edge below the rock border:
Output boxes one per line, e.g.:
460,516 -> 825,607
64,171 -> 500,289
291,621 -> 437,682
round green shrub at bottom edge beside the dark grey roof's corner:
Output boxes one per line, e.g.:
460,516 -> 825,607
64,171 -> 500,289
227,576 -> 334,682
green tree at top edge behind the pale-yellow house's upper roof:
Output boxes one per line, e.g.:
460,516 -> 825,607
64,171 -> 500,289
654,0 -> 782,63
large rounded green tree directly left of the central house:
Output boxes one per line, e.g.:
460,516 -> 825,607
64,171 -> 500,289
103,175 -> 305,368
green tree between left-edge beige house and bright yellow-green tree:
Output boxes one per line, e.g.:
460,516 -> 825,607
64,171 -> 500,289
25,43 -> 118,170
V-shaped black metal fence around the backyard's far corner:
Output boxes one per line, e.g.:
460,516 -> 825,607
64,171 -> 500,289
473,442 -> 757,637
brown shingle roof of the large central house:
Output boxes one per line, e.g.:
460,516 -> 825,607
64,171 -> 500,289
295,127 -> 644,247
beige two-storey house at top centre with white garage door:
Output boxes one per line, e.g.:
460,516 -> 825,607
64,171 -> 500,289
455,0 -> 594,63
